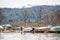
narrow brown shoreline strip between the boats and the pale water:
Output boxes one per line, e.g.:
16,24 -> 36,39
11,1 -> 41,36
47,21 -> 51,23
0,30 -> 60,33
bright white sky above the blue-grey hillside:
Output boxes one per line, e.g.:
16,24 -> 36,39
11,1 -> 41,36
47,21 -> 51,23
0,0 -> 60,8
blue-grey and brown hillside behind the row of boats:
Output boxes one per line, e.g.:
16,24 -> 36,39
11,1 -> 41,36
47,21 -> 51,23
0,5 -> 60,25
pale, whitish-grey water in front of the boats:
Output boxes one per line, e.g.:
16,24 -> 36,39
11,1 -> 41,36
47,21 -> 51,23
0,33 -> 60,40
